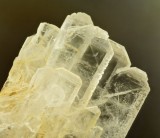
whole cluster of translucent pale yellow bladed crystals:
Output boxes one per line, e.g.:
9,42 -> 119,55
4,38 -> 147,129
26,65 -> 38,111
0,13 -> 150,138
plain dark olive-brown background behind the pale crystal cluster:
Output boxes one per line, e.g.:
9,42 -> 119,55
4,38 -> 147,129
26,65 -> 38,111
0,0 -> 160,138
